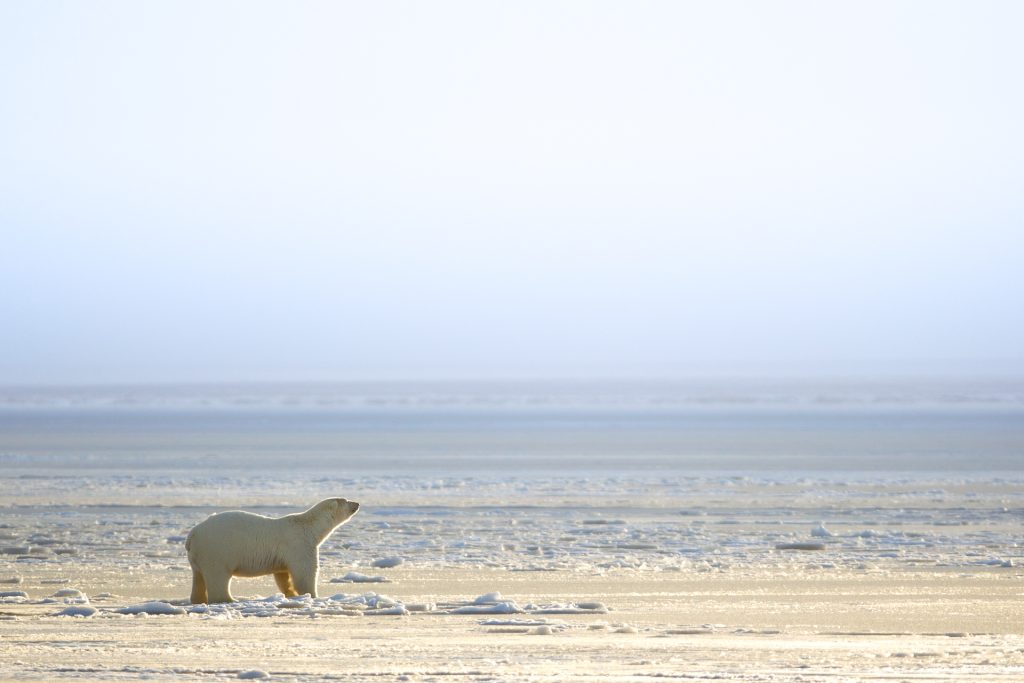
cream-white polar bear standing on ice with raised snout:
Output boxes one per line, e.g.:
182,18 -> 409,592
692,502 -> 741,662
185,498 -> 359,604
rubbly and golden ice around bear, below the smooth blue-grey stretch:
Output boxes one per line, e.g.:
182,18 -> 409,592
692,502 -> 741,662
0,473 -> 1024,681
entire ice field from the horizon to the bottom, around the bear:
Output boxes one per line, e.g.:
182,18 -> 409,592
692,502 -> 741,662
0,385 -> 1024,681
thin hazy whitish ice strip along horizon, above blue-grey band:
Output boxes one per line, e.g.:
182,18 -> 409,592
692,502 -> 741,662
0,378 -> 1024,414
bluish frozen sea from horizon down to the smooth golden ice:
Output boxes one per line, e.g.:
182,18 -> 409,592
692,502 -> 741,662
0,380 -> 1024,580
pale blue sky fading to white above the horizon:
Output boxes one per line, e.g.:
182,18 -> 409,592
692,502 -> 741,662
0,0 -> 1024,384
